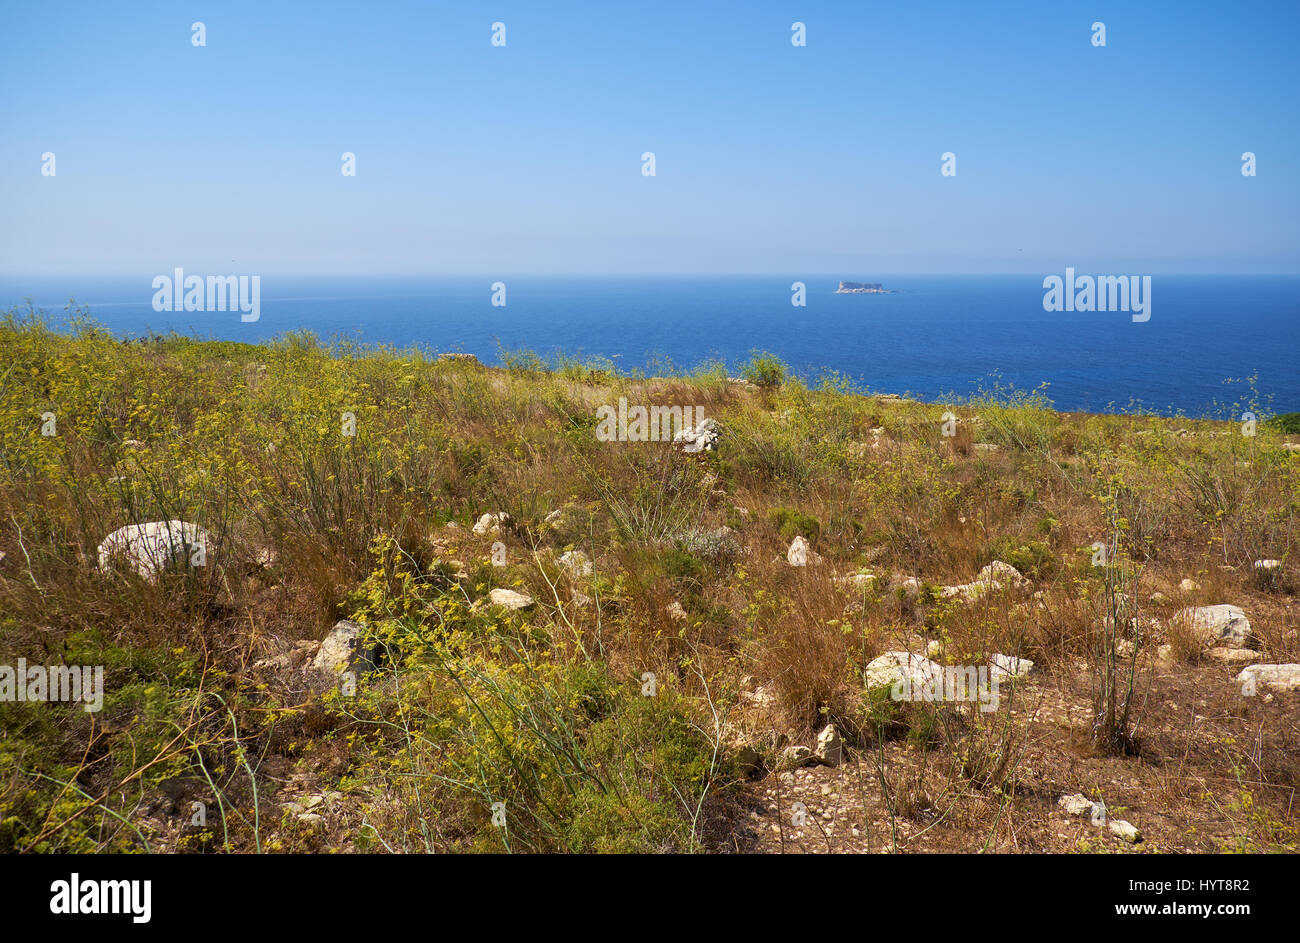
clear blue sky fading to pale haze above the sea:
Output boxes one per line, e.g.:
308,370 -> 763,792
0,0 -> 1300,278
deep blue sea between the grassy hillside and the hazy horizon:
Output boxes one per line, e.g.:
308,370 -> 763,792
0,271 -> 1300,418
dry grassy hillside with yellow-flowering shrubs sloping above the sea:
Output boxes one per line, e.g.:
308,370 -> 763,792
0,315 -> 1300,852
